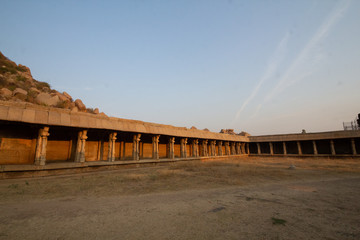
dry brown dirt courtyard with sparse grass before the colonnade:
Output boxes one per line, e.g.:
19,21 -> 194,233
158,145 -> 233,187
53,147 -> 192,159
0,158 -> 360,240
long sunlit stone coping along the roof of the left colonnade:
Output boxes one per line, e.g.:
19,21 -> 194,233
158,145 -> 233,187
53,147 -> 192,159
0,101 -> 249,142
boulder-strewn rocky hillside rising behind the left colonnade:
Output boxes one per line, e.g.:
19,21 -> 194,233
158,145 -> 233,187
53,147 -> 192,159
0,52 -> 105,115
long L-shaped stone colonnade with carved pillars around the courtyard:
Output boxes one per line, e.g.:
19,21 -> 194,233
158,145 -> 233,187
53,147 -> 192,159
0,101 -> 360,177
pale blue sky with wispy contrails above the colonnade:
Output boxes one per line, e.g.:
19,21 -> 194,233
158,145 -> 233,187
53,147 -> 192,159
0,0 -> 360,135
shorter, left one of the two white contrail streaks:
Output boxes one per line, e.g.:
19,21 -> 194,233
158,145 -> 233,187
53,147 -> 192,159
234,33 -> 290,121
